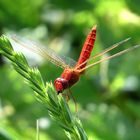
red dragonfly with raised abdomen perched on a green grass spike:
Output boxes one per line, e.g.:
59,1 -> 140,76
11,26 -> 140,94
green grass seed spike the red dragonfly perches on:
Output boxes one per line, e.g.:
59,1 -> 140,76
0,36 -> 87,140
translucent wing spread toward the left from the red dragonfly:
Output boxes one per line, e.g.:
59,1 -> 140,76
8,35 -> 76,69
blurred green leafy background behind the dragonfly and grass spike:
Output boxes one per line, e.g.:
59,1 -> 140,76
0,0 -> 140,140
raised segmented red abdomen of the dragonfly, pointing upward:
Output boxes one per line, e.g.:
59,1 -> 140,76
76,26 -> 96,70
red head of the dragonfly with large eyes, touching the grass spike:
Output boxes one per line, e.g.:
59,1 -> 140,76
54,78 -> 68,94
